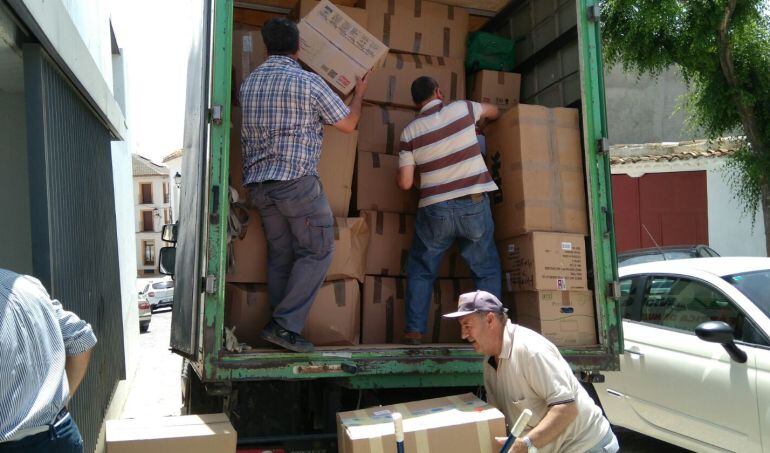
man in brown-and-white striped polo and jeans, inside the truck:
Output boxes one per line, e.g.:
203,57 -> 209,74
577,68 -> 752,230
398,77 -> 502,344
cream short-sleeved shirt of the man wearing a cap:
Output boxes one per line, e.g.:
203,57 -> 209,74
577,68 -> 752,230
484,321 -> 610,453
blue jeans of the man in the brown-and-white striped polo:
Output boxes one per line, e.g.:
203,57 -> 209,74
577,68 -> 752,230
406,194 -> 502,333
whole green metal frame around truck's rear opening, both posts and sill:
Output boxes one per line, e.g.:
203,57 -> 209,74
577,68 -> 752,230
201,0 -> 622,388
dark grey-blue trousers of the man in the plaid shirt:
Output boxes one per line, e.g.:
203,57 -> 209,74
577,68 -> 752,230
249,176 -> 334,333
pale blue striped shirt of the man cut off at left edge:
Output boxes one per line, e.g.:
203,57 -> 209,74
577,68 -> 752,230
0,269 -> 96,442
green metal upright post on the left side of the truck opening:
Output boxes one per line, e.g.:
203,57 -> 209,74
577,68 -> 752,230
201,0 -> 233,380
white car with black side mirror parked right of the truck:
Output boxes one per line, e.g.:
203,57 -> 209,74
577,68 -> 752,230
594,258 -> 770,453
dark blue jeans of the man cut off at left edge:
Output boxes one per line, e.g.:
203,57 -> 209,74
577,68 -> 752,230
0,415 -> 83,453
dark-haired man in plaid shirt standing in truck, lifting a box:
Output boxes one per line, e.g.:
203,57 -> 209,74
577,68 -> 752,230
240,18 -> 366,352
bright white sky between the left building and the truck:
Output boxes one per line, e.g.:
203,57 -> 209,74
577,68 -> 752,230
108,0 -> 199,163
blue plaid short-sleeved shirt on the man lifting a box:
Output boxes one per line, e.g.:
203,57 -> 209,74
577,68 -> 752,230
240,55 -> 350,185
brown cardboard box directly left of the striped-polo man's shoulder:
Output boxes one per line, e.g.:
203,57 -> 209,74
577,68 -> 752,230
358,104 -> 416,155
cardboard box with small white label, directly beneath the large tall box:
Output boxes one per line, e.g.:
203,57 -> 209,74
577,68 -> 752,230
497,232 -> 588,291
